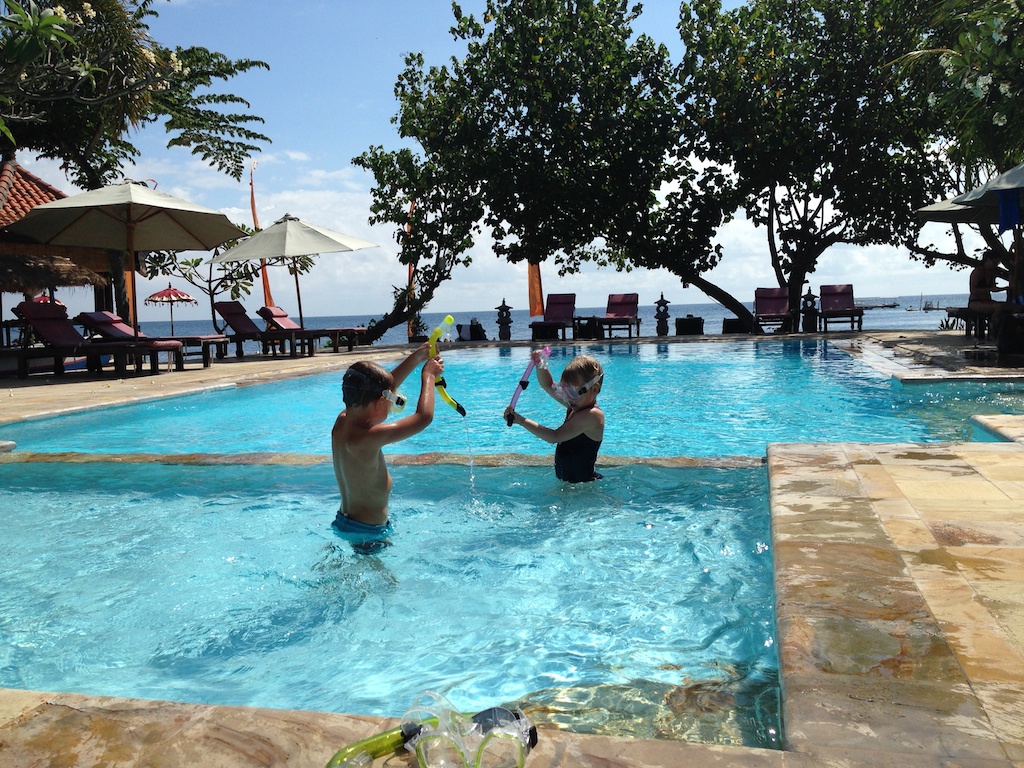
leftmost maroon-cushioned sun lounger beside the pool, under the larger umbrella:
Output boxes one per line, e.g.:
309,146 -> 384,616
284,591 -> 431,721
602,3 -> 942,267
12,301 -> 181,379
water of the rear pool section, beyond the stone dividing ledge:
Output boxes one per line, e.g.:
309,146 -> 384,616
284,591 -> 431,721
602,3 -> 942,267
0,340 -> 1024,457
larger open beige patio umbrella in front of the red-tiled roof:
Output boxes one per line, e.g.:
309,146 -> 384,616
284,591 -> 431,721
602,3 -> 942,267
8,181 -> 245,332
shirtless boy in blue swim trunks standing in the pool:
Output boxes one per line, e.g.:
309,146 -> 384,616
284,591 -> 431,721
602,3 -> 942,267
331,344 -> 444,544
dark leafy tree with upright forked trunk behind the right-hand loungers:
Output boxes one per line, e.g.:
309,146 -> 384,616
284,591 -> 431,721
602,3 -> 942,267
680,0 -> 943,327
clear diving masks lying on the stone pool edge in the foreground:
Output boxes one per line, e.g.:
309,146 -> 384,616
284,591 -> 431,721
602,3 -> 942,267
401,691 -> 537,768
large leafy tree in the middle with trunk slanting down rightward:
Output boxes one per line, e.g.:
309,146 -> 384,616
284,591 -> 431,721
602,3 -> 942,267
365,0 -> 749,335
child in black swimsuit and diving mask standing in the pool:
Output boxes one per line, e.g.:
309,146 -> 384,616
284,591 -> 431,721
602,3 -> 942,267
505,350 -> 604,482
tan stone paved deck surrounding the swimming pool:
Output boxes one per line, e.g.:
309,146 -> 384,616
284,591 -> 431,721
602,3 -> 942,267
0,332 -> 1024,768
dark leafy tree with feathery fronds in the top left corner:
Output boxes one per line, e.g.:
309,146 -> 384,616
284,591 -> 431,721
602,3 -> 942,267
0,0 -> 269,321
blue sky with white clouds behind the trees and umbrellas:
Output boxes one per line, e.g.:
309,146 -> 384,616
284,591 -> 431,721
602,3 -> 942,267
5,0 -> 983,323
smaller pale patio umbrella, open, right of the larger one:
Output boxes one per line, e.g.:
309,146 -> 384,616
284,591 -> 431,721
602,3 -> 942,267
210,214 -> 377,328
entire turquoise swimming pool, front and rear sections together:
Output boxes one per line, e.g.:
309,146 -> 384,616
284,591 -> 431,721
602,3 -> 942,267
6,341 -> 1021,746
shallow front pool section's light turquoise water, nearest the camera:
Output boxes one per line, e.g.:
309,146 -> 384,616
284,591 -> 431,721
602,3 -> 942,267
0,464 -> 780,746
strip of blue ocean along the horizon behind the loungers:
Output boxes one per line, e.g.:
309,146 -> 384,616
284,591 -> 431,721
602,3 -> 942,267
141,293 -> 968,345
